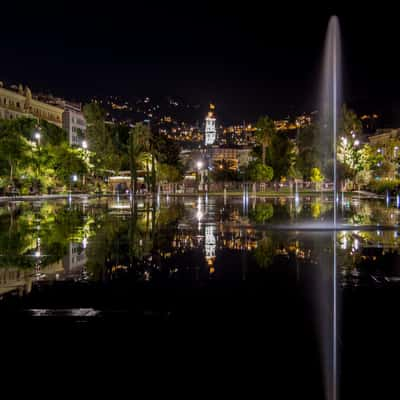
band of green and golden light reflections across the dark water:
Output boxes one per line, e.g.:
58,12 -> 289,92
0,195 -> 400,295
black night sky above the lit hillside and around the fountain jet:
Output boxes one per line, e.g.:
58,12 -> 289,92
0,0 -> 400,126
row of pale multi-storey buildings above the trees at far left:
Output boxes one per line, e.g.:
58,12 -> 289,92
0,82 -> 86,146
